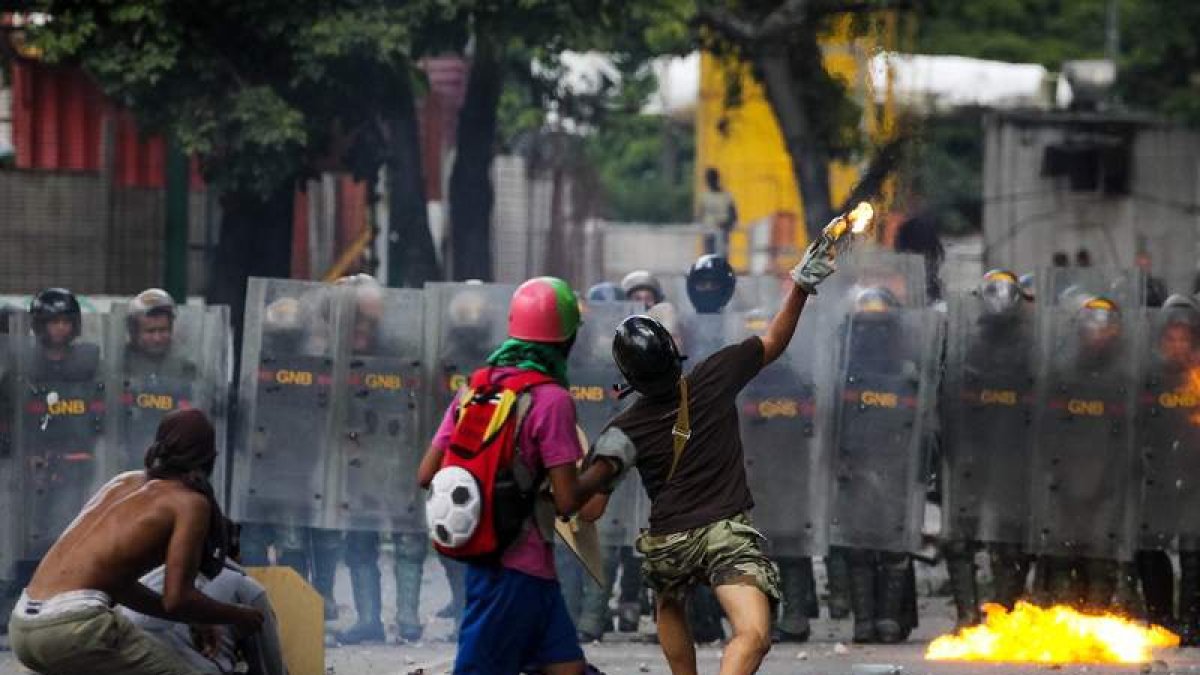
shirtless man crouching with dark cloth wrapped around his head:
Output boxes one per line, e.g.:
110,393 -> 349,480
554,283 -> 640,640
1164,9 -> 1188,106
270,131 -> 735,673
8,410 -> 263,675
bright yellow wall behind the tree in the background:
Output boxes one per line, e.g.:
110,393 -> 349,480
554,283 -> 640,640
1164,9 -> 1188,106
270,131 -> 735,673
696,14 -> 895,271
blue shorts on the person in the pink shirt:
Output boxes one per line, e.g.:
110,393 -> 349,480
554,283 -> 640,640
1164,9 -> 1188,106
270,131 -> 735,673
454,565 -> 583,675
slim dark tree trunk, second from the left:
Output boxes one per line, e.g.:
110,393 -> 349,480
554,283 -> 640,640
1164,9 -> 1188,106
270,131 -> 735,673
386,71 -> 442,288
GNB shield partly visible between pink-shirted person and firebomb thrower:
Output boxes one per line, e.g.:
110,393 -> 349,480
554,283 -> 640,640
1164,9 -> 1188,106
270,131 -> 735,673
568,303 -> 644,546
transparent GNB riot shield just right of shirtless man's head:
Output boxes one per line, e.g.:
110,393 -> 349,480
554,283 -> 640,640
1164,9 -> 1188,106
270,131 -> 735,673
230,279 -> 335,527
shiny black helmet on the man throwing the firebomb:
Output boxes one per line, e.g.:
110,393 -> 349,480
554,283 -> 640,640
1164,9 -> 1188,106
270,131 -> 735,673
612,315 -> 683,398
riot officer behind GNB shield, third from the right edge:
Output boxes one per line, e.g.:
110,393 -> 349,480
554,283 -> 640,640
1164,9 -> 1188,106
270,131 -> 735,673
941,269 -> 1034,628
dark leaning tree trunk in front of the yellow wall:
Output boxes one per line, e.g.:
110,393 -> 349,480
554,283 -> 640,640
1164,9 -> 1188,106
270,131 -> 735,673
755,38 -> 833,240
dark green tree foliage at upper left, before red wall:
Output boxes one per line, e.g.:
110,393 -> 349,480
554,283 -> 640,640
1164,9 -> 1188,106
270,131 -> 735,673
32,0 -> 446,196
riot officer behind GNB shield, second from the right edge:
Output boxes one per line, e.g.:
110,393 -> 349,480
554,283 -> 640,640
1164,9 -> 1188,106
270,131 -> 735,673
1031,286 -> 1133,611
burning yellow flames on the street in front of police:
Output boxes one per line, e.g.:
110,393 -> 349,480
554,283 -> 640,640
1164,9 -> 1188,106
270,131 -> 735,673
925,603 -> 1180,663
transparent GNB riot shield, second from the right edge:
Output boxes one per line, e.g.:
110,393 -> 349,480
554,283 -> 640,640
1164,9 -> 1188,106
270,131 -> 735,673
1030,269 -> 1142,560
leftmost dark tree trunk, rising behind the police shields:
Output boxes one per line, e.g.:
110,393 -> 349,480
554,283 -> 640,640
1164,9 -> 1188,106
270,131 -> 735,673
206,181 -> 295,353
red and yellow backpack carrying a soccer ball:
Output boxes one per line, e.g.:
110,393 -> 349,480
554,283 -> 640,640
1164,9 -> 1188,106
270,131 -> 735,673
431,368 -> 554,563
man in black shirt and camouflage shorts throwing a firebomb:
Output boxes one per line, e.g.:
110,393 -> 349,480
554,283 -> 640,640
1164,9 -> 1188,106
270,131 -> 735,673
592,239 -> 834,675
